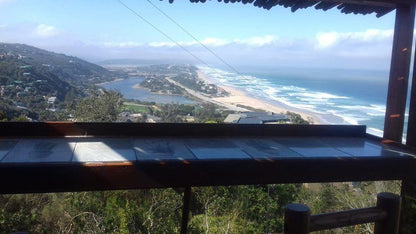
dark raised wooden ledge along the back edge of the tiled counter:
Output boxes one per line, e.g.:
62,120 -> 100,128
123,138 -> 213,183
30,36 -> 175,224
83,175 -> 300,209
0,122 -> 366,137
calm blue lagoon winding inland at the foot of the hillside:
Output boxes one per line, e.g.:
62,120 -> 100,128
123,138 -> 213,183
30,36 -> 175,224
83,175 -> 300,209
101,78 -> 193,104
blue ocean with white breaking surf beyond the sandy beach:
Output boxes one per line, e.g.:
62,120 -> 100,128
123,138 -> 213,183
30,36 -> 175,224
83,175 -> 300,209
200,67 -> 408,135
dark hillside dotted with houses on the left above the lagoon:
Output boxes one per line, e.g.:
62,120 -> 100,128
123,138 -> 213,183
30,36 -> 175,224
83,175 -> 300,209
0,43 -> 112,119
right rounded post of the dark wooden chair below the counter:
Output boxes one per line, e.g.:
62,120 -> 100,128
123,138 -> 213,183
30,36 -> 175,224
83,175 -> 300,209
374,193 -> 401,234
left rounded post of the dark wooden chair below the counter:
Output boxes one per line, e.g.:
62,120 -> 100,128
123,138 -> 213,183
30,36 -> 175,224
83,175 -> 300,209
284,204 -> 311,234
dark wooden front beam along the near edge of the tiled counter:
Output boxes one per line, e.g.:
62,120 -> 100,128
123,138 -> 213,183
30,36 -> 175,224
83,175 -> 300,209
0,156 -> 416,194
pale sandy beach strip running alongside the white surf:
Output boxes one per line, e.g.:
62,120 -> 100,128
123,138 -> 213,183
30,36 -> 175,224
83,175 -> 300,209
198,70 -> 329,124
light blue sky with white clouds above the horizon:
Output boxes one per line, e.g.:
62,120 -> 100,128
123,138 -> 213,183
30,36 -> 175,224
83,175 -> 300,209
0,0 -> 395,70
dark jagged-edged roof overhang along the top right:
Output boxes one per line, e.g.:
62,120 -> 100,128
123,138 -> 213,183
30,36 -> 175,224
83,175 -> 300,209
161,0 -> 414,17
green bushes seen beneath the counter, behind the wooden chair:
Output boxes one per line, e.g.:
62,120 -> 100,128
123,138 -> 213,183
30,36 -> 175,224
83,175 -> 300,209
0,181 -> 404,233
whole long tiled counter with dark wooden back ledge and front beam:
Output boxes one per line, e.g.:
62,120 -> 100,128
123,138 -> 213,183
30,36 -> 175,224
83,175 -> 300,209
0,123 -> 416,193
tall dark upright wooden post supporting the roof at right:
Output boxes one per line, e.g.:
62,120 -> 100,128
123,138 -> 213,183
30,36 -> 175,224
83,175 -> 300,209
383,4 -> 415,142
